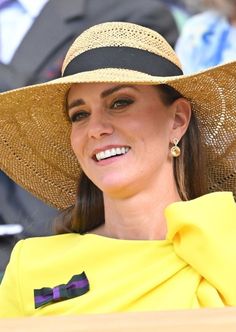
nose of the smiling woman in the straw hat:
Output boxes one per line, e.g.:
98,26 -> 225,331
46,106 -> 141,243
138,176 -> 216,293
88,112 -> 114,139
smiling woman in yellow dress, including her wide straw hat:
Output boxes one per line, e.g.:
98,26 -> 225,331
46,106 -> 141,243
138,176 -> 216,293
0,22 -> 236,317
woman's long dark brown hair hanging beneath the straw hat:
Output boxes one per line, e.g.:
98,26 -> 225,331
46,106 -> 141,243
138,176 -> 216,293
55,84 -> 207,234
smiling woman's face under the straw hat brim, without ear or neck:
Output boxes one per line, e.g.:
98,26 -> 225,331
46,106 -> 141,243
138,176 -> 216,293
67,83 -> 180,197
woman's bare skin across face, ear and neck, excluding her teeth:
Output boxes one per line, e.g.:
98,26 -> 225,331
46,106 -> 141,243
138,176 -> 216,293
67,83 -> 191,240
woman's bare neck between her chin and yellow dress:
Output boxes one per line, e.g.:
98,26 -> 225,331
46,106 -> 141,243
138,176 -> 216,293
94,174 -> 180,240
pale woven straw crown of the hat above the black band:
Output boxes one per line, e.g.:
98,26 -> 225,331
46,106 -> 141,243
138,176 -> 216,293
62,22 -> 181,74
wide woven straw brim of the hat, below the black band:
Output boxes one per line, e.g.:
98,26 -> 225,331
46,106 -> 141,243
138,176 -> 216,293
0,62 -> 236,209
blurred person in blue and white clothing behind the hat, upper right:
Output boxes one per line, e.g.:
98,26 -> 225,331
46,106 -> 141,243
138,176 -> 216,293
175,0 -> 236,73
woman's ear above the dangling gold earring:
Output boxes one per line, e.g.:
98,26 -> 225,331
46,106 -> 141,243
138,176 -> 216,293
170,98 -> 192,141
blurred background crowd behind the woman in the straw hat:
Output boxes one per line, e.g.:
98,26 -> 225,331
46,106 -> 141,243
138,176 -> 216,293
0,0 -> 236,271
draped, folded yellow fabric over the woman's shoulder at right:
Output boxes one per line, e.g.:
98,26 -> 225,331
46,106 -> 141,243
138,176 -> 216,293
165,192 -> 236,305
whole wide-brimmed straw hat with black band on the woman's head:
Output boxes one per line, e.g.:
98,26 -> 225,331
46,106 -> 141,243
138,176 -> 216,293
0,22 -> 236,209
